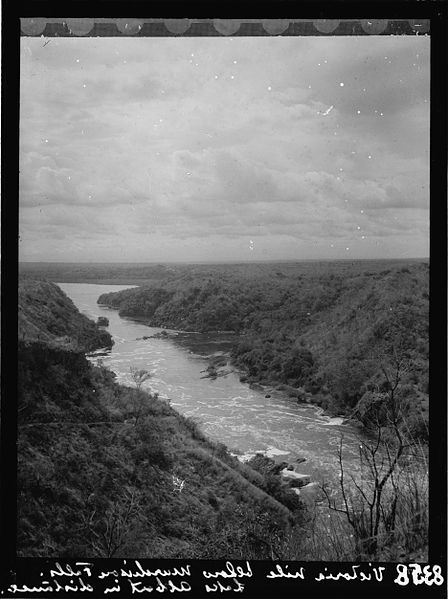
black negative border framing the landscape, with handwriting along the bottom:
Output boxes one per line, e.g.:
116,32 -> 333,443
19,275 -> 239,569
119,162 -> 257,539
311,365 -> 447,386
2,0 -> 448,597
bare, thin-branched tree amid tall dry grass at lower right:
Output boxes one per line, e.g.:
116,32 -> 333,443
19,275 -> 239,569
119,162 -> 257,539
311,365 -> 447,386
322,352 -> 428,558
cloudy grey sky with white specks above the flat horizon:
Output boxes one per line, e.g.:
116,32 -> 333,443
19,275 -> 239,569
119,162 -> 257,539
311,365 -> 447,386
19,36 -> 430,262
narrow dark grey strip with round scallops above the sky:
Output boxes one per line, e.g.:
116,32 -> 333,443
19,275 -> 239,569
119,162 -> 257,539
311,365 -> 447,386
20,17 -> 430,37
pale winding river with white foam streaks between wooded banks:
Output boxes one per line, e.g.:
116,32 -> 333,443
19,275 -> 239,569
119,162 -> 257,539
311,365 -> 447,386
58,283 -> 358,481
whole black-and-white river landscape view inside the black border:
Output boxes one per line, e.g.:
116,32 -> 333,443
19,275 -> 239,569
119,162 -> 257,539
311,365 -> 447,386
13,20 -> 431,580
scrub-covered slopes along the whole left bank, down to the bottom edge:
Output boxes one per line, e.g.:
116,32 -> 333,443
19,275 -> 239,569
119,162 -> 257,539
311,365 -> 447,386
18,282 -> 304,559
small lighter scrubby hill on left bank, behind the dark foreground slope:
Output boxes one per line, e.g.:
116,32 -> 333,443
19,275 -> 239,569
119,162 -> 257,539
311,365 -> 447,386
18,277 -> 113,351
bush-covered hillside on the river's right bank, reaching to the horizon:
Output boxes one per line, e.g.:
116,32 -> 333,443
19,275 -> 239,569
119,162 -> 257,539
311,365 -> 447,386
98,262 -> 429,437
